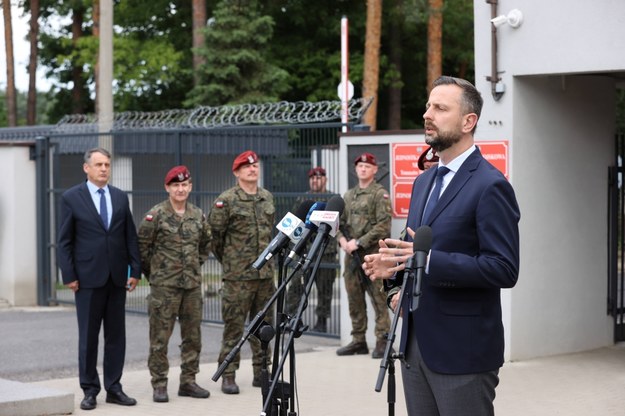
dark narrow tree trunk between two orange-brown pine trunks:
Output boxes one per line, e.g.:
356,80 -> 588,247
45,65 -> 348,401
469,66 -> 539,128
388,0 -> 404,130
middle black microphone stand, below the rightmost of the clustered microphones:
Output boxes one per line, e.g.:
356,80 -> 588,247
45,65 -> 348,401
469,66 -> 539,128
260,238 -> 329,416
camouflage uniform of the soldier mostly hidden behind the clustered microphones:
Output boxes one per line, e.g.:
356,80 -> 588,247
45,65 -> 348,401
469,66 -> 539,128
286,191 -> 338,320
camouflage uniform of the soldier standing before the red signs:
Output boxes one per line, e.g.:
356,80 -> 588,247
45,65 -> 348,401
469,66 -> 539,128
337,182 -> 391,342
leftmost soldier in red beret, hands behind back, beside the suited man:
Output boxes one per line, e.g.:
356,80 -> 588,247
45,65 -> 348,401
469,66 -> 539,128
138,166 -> 211,402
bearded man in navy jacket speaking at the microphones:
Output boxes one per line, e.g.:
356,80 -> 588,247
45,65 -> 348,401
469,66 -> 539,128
364,77 -> 520,416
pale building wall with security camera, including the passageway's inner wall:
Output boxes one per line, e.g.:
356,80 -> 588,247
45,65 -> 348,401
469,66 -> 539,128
474,0 -> 625,360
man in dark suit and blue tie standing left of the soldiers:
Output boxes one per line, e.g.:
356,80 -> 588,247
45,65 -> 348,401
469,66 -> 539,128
58,148 -> 141,410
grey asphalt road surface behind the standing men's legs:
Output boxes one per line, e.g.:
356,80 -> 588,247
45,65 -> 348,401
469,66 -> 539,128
0,306 -> 339,382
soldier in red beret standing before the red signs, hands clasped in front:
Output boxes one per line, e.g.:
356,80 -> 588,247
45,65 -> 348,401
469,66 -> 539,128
336,153 -> 391,358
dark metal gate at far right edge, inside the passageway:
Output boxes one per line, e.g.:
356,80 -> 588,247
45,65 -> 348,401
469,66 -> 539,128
607,134 -> 625,342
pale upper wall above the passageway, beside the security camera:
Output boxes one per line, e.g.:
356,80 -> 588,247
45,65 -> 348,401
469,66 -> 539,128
473,0 -> 625,80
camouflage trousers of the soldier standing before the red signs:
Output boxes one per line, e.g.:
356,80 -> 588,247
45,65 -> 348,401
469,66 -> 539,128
343,255 -> 391,342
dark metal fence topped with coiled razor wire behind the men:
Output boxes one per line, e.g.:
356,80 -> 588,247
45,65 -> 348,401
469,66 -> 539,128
0,98 -> 372,337
